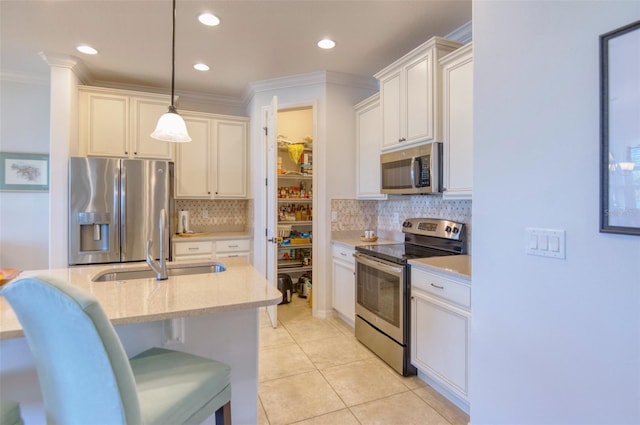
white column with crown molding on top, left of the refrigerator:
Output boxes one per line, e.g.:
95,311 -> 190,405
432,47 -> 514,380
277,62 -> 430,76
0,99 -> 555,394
40,52 -> 81,268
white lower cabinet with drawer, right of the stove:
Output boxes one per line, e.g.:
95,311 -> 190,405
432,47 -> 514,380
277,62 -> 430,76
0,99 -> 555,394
411,266 -> 471,403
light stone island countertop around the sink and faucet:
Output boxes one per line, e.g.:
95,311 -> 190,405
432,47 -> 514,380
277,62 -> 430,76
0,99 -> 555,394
0,258 -> 282,339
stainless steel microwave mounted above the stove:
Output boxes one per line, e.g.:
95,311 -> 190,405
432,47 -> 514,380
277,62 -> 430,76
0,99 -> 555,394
380,142 -> 442,195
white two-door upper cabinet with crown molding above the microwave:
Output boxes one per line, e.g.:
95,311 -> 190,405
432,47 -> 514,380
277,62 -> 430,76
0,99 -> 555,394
375,37 -> 461,150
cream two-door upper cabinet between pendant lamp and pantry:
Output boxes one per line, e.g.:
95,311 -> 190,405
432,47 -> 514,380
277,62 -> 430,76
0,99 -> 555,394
175,112 -> 248,199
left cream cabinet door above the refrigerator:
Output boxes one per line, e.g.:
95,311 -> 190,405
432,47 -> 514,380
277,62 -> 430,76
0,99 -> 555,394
80,93 -> 129,157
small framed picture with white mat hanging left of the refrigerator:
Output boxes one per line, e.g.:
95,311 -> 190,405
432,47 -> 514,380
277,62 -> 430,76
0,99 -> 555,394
0,152 -> 49,191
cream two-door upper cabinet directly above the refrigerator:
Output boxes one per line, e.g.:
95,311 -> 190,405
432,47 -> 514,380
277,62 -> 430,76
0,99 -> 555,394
78,86 -> 173,160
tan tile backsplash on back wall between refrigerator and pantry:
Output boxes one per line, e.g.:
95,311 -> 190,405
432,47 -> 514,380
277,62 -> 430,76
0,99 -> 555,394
175,199 -> 253,232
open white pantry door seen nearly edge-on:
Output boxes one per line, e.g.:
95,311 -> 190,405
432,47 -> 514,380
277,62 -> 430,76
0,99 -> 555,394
262,96 -> 278,328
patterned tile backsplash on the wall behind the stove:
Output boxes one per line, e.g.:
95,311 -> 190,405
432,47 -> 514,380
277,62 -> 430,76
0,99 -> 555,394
331,196 -> 471,252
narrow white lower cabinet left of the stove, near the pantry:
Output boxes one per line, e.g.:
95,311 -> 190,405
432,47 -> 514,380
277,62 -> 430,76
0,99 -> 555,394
331,245 -> 356,326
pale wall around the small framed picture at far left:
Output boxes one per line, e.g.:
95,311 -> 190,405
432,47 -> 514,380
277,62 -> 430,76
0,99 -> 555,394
0,74 -> 49,270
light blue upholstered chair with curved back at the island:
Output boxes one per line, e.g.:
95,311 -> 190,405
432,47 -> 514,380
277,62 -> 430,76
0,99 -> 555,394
2,277 -> 231,425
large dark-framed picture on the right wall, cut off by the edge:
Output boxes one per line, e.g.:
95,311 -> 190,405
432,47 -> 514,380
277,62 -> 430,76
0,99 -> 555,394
600,21 -> 640,235
